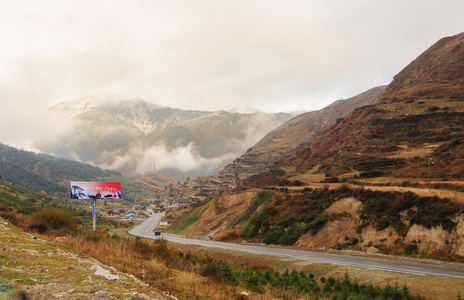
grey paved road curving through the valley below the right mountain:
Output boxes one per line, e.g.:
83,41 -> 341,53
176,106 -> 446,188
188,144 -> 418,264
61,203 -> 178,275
129,215 -> 464,278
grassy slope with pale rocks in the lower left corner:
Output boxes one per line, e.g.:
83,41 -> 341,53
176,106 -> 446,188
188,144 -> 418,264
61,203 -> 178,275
0,219 -> 164,300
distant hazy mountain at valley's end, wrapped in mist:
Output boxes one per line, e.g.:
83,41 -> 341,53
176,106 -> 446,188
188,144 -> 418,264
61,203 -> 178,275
40,95 -> 292,180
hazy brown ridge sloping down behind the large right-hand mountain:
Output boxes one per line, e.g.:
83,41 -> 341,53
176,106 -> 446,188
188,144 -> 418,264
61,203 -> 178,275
219,86 -> 386,181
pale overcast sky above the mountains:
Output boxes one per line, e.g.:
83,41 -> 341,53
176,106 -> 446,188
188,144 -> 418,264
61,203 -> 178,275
0,0 -> 464,150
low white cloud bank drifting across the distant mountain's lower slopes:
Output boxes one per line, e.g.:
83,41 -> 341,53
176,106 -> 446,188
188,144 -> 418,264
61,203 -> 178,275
94,113 -> 281,180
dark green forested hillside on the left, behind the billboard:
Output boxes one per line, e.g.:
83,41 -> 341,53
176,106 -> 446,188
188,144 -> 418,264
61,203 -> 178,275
0,144 -> 177,202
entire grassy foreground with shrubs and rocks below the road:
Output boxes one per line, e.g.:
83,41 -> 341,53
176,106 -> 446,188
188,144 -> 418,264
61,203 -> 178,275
0,217 -> 464,299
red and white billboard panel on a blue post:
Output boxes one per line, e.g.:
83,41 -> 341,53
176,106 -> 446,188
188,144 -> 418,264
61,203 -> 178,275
71,181 -> 121,199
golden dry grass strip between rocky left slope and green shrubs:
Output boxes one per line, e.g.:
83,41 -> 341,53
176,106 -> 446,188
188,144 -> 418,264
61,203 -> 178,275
48,236 -> 272,299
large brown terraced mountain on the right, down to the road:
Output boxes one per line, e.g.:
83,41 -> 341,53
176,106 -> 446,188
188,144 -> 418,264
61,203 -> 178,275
169,33 -> 464,259
